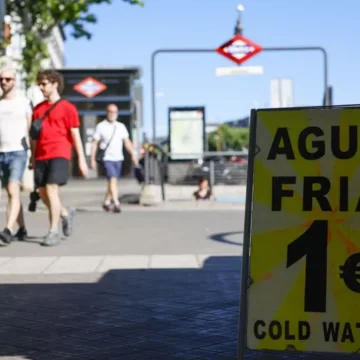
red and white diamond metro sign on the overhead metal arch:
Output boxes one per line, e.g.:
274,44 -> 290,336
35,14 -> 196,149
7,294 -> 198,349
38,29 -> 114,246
216,35 -> 263,65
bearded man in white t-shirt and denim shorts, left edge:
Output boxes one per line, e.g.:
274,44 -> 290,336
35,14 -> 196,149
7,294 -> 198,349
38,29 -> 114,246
0,69 -> 32,244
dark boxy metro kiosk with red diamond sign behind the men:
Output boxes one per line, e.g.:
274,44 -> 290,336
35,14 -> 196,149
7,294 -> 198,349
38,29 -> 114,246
57,67 -> 143,177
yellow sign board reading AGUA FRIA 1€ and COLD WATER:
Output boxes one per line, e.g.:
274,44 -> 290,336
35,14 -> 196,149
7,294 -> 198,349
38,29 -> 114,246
247,107 -> 360,353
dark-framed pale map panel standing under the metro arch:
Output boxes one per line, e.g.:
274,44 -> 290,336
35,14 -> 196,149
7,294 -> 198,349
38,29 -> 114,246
169,107 -> 205,160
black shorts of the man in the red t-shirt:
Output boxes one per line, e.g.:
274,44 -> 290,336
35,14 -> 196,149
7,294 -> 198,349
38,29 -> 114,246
34,158 -> 69,188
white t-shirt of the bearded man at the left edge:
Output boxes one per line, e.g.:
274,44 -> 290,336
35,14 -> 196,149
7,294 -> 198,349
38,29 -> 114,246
0,97 -> 32,152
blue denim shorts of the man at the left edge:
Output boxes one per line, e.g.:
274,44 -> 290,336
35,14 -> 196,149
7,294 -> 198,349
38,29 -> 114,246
0,150 -> 28,188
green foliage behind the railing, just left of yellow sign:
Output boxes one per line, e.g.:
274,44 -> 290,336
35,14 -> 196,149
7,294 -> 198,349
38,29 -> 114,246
208,125 -> 249,151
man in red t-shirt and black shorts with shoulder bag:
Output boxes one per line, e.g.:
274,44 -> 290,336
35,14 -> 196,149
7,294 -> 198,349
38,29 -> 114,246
31,70 -> 88,246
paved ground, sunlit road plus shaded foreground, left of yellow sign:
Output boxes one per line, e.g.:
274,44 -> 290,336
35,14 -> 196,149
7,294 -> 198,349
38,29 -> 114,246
0,202 -> 358,360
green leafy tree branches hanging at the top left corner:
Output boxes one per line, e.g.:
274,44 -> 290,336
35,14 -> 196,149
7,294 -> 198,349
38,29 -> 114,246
2,0 -> 144,86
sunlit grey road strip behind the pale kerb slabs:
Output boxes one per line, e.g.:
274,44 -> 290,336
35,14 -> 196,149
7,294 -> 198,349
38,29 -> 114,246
0,209 -> 244,258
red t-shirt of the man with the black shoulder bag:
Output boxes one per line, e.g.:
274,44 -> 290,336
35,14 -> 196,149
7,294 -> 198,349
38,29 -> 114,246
33,100 -> 80,160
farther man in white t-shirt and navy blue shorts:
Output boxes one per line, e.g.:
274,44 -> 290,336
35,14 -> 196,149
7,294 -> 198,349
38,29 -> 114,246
91,104 -> 138,213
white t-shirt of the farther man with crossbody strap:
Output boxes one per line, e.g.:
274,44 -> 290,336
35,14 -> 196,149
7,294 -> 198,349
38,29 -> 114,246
93,119 -> 129,161
